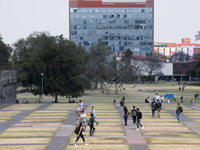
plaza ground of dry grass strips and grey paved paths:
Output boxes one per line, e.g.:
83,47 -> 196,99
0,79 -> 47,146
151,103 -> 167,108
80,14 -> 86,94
0,103 -> 200,150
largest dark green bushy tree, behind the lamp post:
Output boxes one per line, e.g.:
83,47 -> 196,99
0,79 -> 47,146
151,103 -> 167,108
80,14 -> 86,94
12,33 -> 84,100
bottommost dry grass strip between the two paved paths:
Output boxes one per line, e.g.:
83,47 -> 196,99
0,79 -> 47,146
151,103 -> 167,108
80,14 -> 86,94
64,144 -> 130,150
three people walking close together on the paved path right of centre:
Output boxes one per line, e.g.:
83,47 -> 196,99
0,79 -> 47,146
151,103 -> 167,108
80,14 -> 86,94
123,106 -> 144,130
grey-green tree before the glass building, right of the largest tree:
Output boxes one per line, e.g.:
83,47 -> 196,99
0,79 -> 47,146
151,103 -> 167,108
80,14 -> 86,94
85,39 -> 113,88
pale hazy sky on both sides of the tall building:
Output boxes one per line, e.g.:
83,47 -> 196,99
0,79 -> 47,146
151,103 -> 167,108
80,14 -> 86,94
0,0 -> 200,44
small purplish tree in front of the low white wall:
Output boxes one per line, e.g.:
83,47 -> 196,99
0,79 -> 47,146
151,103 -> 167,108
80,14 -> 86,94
144,57 -> 163,81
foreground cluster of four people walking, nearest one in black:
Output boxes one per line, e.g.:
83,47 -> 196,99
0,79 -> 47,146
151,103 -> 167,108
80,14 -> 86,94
74,100 -> 99,146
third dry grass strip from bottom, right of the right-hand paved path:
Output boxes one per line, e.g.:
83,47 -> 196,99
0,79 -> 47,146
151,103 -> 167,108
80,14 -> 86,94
142,132 -> 198,137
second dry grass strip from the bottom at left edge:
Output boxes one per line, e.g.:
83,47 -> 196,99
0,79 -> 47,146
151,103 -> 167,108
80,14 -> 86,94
0,138 -> 51,144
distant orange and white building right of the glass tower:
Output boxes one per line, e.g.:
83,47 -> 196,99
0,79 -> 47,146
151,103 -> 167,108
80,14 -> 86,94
154,38 -> 200,58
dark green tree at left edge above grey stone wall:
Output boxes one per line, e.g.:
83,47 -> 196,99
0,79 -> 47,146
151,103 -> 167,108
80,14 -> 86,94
0,35 -> 12,70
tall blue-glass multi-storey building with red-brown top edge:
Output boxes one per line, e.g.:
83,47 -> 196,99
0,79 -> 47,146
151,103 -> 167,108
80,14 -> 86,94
69,0 -> 154,56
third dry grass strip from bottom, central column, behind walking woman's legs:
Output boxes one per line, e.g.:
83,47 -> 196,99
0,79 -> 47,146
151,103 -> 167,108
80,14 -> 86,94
71,131 -> 126,137
